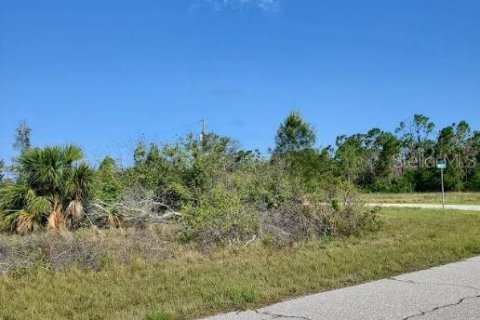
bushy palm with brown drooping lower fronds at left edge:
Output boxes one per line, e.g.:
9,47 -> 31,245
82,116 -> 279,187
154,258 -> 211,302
0,145 -> 94,233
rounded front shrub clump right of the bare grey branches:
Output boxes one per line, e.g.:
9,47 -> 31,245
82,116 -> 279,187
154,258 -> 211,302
182,158 -> 376,247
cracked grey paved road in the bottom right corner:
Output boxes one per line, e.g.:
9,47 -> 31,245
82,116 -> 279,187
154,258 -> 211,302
200,256 -> 480,320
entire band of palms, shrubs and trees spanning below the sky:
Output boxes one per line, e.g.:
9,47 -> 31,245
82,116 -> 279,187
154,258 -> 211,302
0,111 -> 480,236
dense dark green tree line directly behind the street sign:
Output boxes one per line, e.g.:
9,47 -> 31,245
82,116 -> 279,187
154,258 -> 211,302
334,114 -> 480,192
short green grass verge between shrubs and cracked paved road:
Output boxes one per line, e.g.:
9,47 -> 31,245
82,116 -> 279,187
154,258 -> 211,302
0,209 -> 480,320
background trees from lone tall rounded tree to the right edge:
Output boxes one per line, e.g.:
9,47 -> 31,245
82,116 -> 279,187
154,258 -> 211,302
272,111 -> 480,193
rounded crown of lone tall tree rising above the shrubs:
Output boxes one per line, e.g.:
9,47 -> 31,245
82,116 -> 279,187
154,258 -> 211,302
274,110 -> 316,154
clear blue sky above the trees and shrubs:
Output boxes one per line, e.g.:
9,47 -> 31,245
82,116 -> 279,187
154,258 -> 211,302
0,0 -> 480,164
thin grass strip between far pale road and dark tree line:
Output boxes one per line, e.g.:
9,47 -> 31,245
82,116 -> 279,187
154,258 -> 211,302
362,192 -> 480,205
